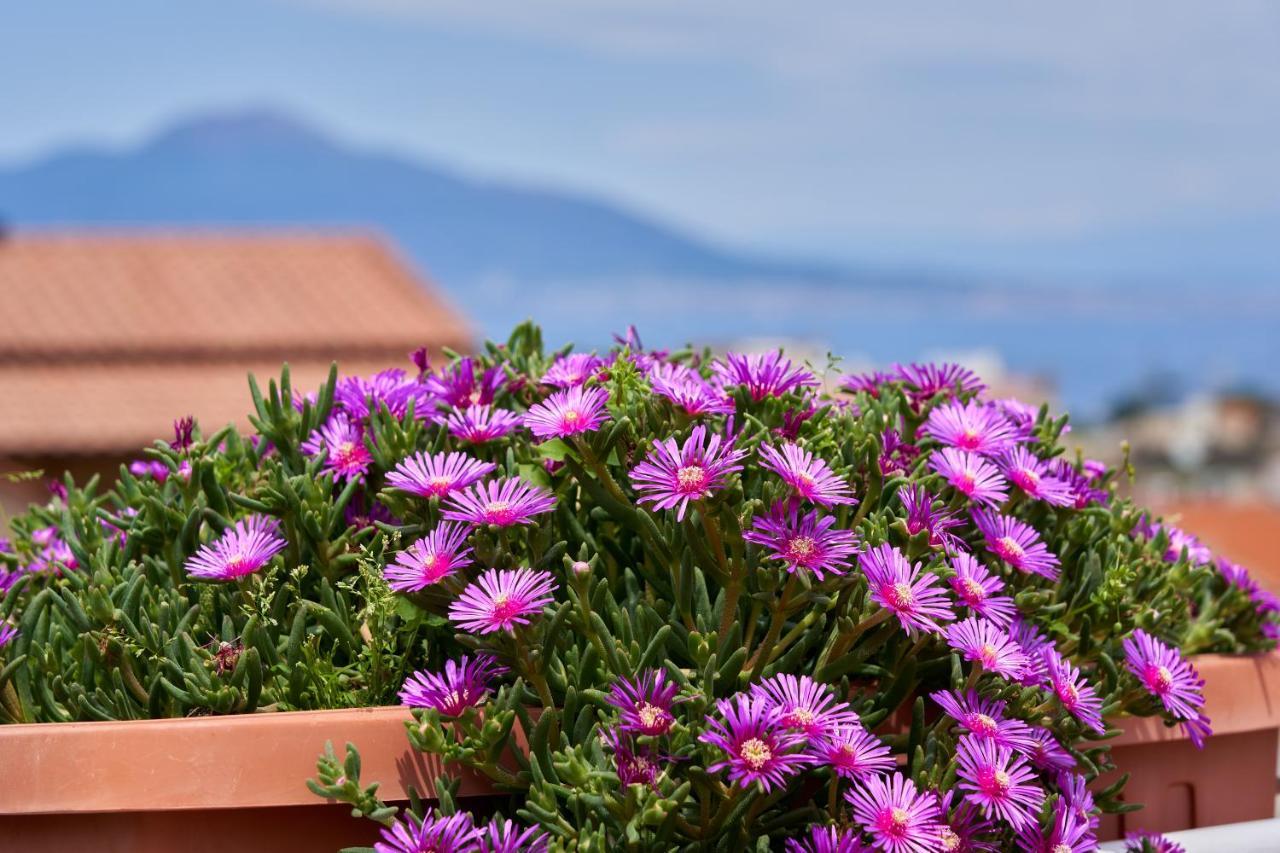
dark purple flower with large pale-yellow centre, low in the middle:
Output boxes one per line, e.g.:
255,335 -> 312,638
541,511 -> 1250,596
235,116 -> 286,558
698,693 -> 812,793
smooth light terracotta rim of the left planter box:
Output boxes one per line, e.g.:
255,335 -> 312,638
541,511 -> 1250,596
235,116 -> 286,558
0,706 -> 493,815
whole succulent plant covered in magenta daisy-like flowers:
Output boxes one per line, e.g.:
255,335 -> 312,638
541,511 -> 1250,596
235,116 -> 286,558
0,325 -> 1277,853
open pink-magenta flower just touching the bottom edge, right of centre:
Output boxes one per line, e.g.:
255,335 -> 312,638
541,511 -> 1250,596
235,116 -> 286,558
845,774 -> 942,853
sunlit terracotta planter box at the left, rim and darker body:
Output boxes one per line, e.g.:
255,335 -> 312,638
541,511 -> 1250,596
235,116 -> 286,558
0,707 -> 504,853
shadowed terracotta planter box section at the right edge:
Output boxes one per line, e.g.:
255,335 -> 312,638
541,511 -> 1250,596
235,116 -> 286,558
1098,653 -> 1280,840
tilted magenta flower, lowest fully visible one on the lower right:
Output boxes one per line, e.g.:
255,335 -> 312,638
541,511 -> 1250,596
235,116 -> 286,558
956,735 -> 1044,831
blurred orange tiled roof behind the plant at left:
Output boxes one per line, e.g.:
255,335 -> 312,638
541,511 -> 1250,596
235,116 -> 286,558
0,232 -> 471,456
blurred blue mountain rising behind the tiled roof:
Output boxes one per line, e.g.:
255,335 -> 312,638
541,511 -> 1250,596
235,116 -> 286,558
0,110 -> 890,284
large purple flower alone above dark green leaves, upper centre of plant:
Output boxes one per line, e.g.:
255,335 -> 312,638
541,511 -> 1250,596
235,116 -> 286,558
631,425 -> 746,521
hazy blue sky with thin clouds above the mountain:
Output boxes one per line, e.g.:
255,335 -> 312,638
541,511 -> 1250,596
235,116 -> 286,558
0,0 -> 1280,272
